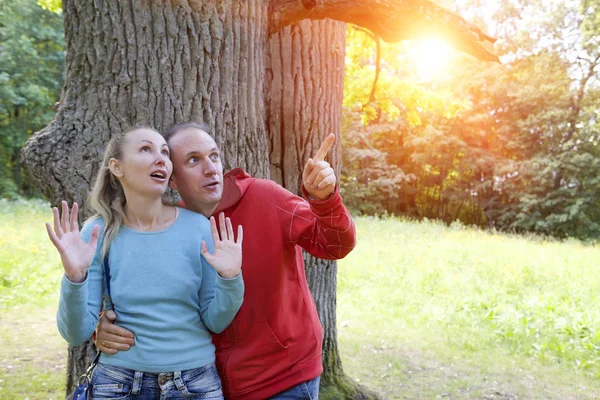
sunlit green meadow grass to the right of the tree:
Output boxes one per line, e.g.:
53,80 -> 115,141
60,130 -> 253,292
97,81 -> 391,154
338,217 -> 600,399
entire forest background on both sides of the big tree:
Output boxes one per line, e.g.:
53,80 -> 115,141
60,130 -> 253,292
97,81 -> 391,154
0,0 -> 600,240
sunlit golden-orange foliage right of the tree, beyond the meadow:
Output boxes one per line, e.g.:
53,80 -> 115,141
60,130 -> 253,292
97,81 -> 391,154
341,0 -> 600,239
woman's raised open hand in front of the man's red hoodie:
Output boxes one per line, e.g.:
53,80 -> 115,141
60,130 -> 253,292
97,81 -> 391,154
202,213 -> 244,279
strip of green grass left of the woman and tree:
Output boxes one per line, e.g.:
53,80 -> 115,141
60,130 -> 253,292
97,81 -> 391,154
0,200 -> 67,400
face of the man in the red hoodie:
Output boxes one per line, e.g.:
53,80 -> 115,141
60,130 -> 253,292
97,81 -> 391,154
169,128 -> 223,217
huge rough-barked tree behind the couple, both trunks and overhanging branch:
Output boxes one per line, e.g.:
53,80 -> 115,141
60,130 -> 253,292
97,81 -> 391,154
22,0 -> 493,398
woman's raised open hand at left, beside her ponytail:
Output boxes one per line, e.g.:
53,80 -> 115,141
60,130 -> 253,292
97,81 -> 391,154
46,201 -> 100,283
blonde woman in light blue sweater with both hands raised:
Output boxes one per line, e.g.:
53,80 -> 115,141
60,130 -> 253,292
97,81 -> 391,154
46,128 -> 244,399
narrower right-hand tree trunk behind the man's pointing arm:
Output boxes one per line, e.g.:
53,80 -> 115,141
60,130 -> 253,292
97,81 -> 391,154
265,20 -> 376,399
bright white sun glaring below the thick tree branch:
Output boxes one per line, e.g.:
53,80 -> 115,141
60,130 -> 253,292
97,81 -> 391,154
407,39 -> 453,82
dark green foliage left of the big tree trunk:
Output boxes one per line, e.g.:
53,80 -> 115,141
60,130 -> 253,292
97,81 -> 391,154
0,0 -> 65,198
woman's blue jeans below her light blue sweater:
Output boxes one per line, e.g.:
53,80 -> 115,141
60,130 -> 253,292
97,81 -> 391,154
91,363 -> 223,400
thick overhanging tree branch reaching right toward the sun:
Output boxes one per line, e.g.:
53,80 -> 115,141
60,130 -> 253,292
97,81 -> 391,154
269,0 -> 499,62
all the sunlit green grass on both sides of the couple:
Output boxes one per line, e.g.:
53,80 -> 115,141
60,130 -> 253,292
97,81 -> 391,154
0,200 -> 600,399
